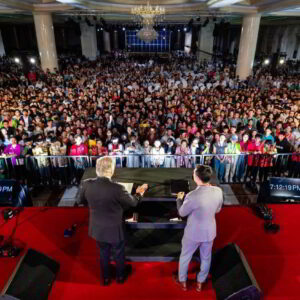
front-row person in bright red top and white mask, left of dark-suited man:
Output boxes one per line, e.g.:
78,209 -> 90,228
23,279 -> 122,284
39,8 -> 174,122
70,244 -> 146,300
70,135 -> 89,184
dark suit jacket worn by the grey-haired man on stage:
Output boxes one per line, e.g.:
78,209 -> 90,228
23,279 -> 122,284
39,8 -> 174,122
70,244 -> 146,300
78,177 -> 140,243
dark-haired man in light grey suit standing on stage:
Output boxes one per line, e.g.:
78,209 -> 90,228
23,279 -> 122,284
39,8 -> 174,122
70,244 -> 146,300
176,165 -> 223,292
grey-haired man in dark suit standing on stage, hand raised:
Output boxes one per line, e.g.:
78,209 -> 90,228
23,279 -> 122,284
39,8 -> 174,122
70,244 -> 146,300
79,157 -> 148,285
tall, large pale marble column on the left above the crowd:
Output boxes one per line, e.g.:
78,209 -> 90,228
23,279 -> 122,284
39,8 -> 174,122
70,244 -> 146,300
33,12 -> 58,71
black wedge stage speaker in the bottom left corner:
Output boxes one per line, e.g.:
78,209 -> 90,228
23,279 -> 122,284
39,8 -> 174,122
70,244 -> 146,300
2,249 -> 59,300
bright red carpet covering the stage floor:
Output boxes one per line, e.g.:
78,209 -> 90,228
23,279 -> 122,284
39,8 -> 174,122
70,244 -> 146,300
0,205 -> 300,300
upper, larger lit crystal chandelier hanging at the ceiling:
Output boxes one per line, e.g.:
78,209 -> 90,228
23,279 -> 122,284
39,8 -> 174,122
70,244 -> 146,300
131,2 -> 165,25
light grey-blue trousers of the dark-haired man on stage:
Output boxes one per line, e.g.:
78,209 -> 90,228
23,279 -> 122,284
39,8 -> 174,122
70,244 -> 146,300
178,236 -> 214,283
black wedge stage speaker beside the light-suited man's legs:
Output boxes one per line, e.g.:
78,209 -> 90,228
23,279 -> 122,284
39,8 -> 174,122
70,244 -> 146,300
211,244 -> 262,300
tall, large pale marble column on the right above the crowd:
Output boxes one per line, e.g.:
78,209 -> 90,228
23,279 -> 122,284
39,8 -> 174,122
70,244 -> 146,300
236,14 -> 261,80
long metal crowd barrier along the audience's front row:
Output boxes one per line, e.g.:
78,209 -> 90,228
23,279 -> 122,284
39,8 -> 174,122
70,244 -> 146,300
0,153 -> 300,186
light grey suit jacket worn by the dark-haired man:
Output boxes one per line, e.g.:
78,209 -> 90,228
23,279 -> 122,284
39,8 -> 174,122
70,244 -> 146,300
177,186 -> 223,242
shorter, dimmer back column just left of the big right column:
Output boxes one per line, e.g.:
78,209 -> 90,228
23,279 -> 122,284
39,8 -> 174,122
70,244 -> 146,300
198,22 -> 215,61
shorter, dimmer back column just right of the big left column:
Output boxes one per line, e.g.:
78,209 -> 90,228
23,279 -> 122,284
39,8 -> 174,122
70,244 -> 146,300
80,23 -> 98,60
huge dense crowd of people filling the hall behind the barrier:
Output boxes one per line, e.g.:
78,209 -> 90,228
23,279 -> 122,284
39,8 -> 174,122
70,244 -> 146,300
0,53 -> 300,184
